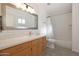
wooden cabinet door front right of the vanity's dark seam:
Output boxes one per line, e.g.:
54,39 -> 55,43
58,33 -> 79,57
32,39 -> 43,56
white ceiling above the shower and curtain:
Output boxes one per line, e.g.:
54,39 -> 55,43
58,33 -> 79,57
29,3 -> 72,16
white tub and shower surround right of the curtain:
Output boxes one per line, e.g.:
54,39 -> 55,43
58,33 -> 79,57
52,13 -> 72,48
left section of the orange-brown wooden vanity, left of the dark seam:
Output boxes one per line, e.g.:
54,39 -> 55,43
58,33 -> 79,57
0,42 -> 31,56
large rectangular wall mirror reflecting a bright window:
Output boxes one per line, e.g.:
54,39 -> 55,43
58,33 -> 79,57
5,6 -> 38,29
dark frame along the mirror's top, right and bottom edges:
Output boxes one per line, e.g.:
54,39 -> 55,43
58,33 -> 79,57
3,3 -> 38,30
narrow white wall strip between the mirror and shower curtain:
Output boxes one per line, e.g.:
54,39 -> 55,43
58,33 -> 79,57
38,4 -> 47,35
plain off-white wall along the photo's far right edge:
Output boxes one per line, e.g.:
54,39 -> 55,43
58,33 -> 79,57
72,3 -> 79,52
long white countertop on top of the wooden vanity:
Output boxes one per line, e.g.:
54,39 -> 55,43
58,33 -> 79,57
0,35 -> 45,50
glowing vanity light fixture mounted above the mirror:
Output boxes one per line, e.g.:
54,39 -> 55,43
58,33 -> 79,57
12,3 -> 36,14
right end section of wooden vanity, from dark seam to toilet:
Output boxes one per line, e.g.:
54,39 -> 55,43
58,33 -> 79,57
32,37 -> 47,56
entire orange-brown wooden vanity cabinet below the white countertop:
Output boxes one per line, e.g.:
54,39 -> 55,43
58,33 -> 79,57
0,37 -> 47,56
